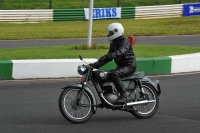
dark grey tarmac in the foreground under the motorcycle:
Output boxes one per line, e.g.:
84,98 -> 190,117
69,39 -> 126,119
0,73 -> 200,133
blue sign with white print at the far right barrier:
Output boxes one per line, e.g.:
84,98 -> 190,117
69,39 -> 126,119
183,3 -> 200,16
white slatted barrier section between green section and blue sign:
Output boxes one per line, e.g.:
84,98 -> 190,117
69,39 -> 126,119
135,4 -> 183,19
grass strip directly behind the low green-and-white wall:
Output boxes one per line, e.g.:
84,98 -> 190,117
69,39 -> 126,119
0,44 -> 200,60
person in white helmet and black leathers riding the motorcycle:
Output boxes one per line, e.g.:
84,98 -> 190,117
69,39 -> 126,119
91,23 -> 136,103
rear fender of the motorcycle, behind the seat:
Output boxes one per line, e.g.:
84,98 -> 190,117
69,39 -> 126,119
141,77 -> 161,96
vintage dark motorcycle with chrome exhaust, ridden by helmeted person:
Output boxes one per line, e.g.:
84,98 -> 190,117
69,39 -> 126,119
59,55 -> 161,123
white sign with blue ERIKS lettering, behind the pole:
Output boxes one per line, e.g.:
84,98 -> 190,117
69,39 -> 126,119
84,7 -> 121,20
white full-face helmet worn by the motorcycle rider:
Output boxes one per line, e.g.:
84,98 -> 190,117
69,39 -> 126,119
107,23 -> 124,42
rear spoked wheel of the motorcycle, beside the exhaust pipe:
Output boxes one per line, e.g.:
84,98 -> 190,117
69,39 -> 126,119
130,84 -> 159,119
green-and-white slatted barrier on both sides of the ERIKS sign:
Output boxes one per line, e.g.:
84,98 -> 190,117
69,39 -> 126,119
0,4 -> 191,23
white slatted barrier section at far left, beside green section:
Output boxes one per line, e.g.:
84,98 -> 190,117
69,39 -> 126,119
0,9 -> 53,23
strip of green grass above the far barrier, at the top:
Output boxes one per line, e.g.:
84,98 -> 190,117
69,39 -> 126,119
0,0 -> 199,10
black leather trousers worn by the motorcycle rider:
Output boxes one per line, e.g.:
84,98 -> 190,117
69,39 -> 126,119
110,66 -> 136,96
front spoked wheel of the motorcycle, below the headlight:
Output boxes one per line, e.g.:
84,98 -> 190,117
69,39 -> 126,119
59,88 -> 93,123
